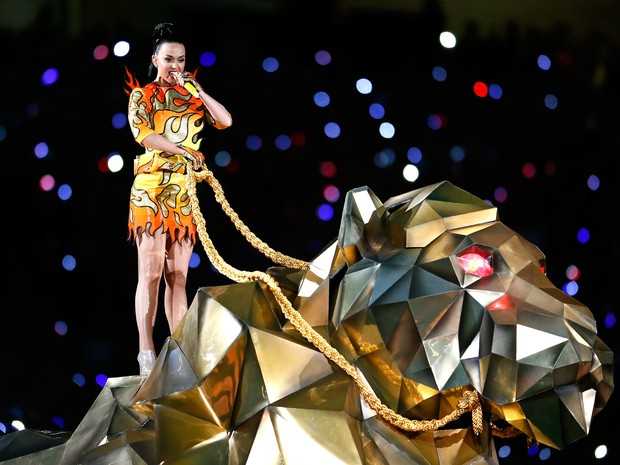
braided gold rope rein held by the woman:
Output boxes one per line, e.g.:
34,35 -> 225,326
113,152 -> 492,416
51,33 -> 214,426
185,163 -> 483,434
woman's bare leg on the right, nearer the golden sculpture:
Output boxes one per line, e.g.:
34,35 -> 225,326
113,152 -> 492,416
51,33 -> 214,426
164,238 -> 194,334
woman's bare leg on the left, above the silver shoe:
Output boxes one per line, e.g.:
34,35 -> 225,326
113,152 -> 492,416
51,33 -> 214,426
136,232 -> 166,350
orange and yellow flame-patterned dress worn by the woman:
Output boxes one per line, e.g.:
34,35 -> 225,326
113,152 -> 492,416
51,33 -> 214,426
128,83 -> 213,243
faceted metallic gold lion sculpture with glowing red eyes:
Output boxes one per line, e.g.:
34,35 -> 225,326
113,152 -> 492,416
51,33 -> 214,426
0,182 -> 614,465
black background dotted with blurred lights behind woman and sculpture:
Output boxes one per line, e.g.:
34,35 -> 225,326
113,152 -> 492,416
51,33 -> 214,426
0,0 -> 620,463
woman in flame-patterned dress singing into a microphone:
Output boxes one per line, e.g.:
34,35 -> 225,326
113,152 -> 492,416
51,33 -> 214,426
128,23 -> 232,376
